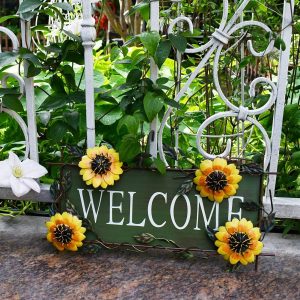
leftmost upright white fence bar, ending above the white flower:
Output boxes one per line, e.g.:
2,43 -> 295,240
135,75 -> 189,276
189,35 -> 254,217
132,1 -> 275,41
20,0 -> 39,162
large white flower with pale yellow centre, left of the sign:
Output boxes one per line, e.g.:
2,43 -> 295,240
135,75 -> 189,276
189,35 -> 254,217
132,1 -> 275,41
0,152 -> 47,197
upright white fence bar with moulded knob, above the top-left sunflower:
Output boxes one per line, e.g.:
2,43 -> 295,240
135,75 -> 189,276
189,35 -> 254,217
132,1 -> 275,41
81,0 -> 96,148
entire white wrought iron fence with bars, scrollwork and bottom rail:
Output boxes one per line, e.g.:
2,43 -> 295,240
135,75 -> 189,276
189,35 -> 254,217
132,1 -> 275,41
0,0 -> 300,218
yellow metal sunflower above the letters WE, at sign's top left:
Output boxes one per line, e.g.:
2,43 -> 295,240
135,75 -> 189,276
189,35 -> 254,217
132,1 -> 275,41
79,146 -> 123,189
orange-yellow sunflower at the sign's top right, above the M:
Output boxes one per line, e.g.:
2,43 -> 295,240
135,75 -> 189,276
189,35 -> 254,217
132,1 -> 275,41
194,158 -> 242,203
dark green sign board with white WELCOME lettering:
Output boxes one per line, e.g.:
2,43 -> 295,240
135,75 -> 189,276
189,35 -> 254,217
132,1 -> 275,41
61,166 -> 261,250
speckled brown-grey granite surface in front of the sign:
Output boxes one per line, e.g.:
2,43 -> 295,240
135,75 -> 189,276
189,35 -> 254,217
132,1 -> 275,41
0,218 -> 300,300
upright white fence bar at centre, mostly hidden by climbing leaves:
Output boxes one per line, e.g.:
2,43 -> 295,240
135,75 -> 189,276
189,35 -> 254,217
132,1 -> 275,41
149,1 -> 159,157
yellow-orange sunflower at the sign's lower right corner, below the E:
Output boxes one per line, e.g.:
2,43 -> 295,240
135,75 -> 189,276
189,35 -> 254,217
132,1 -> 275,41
215,218 -> 263,265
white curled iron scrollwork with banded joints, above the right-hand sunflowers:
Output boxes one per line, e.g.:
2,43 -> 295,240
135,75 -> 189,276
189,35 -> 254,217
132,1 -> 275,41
158,0 -> 284,170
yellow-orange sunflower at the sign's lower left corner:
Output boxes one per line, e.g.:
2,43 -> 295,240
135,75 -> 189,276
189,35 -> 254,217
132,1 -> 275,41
46,212 -> 86,251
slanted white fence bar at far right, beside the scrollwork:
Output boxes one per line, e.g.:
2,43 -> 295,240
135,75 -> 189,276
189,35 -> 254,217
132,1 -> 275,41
266,1 -> 294,198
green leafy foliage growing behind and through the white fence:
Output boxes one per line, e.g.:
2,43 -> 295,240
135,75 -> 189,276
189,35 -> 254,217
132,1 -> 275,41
0,0 -> 300,219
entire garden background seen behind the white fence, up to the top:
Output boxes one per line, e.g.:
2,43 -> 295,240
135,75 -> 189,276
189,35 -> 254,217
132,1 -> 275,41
0,0 -> 300,233
